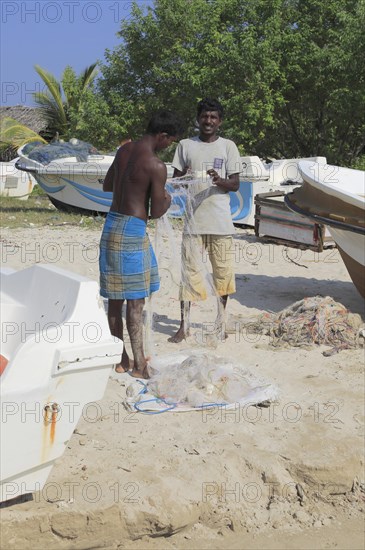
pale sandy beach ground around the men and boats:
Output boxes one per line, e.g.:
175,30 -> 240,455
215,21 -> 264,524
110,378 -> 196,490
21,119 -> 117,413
0,226 -> 365,550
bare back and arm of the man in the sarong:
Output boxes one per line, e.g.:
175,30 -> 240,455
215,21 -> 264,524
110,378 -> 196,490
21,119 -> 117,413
103,135 -> 171,221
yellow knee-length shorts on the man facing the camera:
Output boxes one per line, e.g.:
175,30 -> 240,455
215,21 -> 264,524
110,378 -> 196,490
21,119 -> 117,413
180,235 -> 236,302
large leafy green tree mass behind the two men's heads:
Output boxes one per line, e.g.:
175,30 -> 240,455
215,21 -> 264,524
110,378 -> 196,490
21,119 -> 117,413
94,0 -> 365,164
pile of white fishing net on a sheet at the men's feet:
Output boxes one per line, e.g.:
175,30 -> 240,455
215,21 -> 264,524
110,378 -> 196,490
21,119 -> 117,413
127,351 -> 278,412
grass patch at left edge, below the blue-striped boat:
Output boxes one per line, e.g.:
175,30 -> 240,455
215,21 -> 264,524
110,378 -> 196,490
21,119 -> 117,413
0,189 -> 105,229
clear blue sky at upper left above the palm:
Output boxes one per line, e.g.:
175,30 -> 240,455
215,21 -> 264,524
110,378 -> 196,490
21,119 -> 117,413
0,0 -> 151,105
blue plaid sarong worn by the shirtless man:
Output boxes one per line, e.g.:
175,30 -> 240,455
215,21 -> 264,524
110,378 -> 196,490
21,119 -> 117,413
99,212 -> 160,300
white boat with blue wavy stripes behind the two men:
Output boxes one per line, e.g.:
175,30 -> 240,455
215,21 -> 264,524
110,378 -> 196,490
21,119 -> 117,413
17,139 -> 326,227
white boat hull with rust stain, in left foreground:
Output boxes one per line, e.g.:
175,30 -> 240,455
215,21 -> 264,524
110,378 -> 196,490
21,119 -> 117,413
0,264 -> 123,501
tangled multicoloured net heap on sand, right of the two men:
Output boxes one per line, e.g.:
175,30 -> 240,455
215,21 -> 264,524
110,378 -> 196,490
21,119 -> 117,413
246,296 -> 364,355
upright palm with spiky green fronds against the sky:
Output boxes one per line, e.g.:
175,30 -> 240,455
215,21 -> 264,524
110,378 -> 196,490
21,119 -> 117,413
33,63 -> 98,139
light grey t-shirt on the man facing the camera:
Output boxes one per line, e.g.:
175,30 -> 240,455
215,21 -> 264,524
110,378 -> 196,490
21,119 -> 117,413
172,137 -> 241,235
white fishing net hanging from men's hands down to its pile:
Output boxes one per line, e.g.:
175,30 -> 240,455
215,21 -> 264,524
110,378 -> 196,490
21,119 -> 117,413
126,175 -> 278,414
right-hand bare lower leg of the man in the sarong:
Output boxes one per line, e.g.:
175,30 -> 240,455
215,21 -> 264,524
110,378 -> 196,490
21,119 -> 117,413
127,298 -> 148,378
